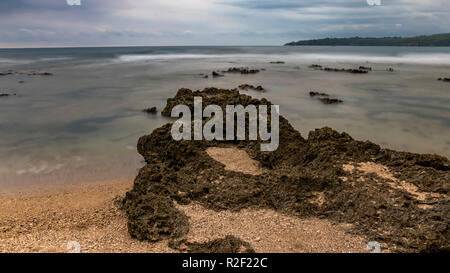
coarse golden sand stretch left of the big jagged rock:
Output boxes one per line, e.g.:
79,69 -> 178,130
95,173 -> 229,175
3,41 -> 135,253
0,181 -> 174,253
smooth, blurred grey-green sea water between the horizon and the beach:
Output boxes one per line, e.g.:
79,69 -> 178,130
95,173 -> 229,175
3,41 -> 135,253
0,47 -> 450,189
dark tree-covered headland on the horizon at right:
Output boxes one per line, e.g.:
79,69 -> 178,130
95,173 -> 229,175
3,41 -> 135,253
285,33 -> 450,46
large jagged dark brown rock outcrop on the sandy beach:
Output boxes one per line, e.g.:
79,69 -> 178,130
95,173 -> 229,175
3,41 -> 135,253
122,88 -> 450,252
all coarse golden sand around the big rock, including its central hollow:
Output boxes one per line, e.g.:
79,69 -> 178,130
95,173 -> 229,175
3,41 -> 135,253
0,148 -> 374,253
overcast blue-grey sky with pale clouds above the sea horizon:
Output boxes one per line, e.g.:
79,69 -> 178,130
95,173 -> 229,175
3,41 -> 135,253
0,0 -> 450,47
